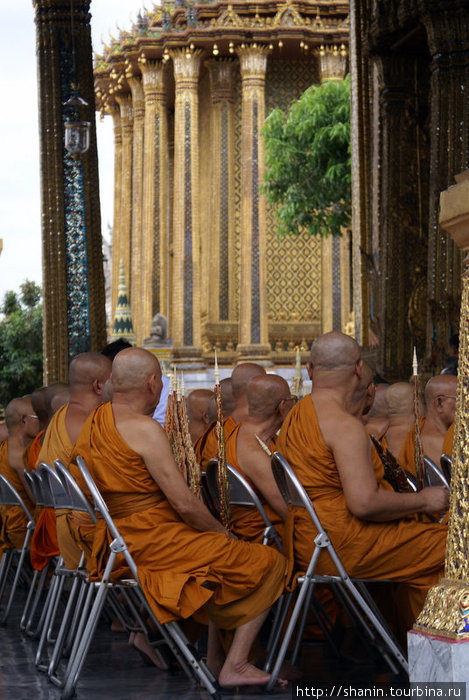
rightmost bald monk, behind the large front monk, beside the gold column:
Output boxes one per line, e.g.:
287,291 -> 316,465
400,374 -> 457,475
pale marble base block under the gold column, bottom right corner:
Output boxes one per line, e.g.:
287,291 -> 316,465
407,630 -> 469,692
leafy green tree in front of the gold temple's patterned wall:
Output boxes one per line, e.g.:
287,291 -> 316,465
262,76 -> 351,236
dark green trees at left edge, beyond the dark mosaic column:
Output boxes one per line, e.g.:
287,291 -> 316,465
0,280 -> 42,407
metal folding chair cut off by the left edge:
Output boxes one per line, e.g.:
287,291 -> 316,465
0,474 -> 35,625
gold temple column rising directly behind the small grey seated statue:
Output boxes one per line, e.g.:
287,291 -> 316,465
140,60 -> 169,337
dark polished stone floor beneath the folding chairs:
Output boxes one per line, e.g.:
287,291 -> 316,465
0,600 -> 402,700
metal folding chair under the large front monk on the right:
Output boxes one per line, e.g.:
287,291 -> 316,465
266,452 -> 408,690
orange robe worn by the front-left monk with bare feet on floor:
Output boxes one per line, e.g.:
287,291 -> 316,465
71,403 -> 286,629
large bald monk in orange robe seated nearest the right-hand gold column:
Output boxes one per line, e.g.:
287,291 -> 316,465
277,332 -> 448,628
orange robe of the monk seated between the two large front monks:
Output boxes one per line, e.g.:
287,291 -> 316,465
225,423 -> 284,543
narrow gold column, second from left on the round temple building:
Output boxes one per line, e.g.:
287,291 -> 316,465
112,94 -> 133,318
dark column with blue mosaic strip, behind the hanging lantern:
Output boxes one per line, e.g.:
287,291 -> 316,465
33,0 -> 106,384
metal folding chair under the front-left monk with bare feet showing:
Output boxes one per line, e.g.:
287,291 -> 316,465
62,457 -> 219,700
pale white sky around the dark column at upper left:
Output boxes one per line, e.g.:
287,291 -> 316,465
0,0 -> 149,301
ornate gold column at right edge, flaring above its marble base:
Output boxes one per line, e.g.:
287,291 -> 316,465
414,170 -> 469,660
